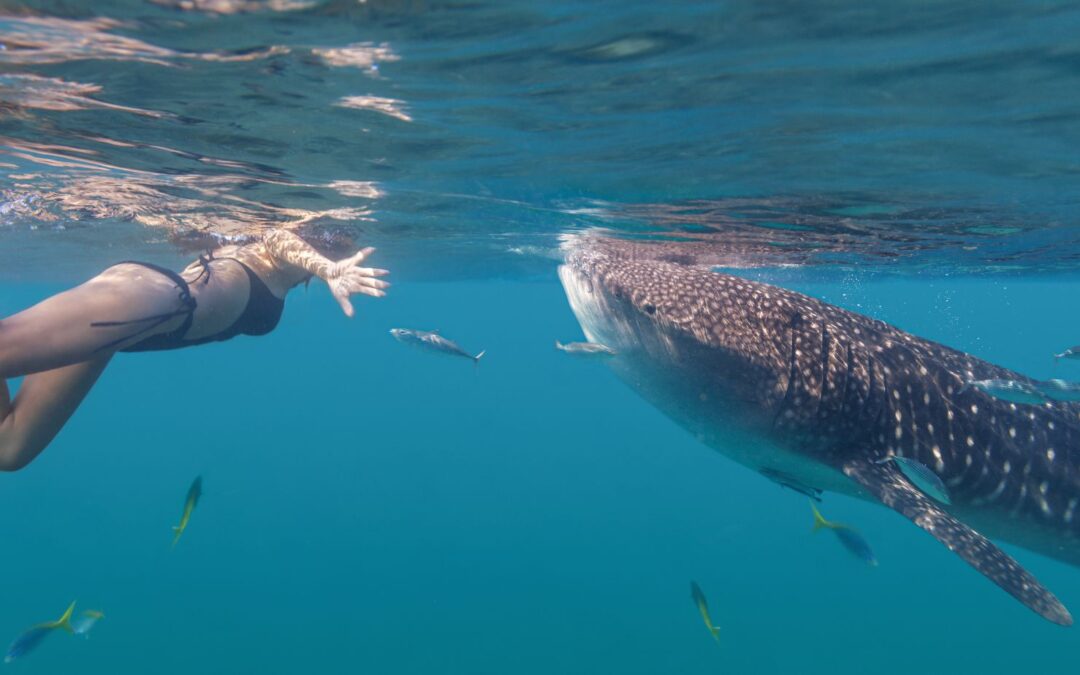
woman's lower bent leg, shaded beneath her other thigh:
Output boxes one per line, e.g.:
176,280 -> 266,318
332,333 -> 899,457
0,352 -> 112,471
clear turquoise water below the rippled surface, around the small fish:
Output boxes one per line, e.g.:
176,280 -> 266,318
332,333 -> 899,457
6,278 -> 1080,673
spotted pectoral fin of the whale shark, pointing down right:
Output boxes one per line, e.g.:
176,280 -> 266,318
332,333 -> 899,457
842,460 -> 1072,625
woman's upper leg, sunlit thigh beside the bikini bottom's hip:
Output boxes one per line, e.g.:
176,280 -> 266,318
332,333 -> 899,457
0,264 -> 186,379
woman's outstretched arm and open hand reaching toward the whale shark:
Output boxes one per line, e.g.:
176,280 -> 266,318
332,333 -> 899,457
262,230 -> 390,316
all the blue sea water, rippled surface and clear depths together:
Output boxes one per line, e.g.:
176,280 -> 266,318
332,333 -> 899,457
6,0 -> 1080,675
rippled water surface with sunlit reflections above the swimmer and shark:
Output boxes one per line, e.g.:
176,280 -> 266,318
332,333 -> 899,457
0,0 -> 1080,278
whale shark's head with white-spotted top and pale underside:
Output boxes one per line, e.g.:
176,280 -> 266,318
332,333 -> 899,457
558,235 -> 791,442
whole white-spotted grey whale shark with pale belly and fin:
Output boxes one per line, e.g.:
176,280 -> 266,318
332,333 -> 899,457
559,237 -> 1080,625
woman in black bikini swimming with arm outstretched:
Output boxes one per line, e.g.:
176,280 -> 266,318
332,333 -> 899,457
0,230 -> 389,471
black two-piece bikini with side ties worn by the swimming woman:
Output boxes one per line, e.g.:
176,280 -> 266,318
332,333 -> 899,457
91,256 -> 285,352
